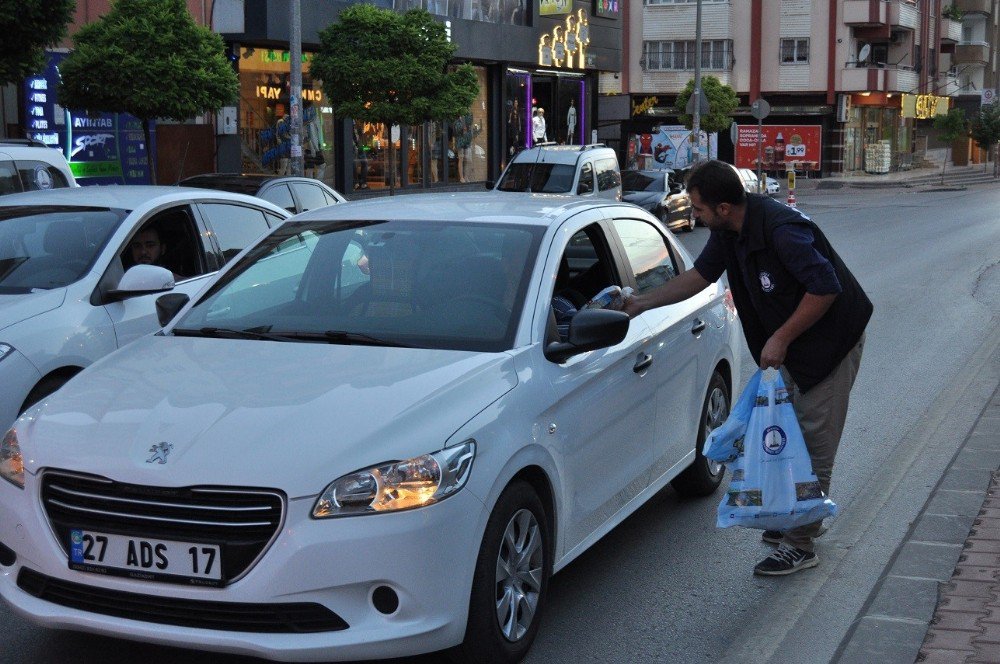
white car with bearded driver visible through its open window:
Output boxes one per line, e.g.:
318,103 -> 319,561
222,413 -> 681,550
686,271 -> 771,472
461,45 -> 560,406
0,186 -> 289,430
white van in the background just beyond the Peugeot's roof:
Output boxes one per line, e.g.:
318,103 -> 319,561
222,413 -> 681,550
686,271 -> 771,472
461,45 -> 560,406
486,143 -> 622,201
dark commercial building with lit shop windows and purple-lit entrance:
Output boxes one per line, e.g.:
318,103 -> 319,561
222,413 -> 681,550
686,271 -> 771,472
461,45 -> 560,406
213,0 -> 622,193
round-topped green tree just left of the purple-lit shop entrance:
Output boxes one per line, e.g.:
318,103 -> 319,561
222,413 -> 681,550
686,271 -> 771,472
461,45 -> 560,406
310,3 -> 479,195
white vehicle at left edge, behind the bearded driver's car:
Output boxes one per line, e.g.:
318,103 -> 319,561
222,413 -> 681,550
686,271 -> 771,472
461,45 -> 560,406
0,138 -> 79,195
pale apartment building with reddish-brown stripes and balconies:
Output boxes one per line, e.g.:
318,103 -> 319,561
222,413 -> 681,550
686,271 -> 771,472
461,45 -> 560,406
620,0 -> 997,174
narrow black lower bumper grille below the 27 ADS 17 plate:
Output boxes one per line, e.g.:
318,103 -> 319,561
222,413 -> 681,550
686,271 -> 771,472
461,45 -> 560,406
17,568 -> 348,634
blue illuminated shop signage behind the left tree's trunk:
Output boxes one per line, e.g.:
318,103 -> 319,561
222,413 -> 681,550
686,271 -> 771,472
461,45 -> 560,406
24,52 -> 156,184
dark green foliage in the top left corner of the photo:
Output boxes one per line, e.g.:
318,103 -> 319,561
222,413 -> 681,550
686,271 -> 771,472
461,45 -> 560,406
0,0 -> 76,85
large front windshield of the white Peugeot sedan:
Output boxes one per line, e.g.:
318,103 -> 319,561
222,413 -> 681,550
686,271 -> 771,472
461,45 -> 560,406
173,220 -> 544,352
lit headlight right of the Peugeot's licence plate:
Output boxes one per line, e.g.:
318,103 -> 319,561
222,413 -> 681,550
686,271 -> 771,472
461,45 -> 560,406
313,440 -> 476,519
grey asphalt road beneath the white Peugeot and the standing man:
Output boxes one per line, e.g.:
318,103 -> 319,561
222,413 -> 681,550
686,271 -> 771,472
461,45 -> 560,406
0,186 -> 1000,664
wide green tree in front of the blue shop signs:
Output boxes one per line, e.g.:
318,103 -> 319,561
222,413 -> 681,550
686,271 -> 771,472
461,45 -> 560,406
59,0 -> 239,183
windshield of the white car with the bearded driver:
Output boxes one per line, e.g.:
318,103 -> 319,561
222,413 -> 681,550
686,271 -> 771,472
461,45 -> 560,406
0,205 -> 128,294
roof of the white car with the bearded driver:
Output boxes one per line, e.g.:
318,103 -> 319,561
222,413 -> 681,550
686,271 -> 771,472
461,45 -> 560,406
0,184 -> 288,210
